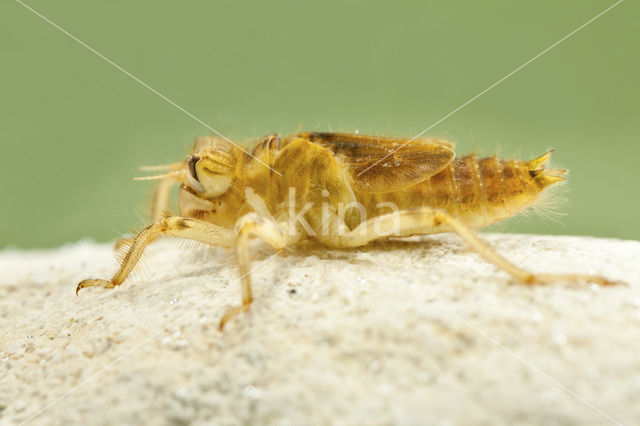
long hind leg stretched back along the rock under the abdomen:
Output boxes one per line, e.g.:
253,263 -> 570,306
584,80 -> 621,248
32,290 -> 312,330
324,207 -> 620,285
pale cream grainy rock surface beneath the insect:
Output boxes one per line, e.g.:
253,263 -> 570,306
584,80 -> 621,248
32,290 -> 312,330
0,234 -> 640,425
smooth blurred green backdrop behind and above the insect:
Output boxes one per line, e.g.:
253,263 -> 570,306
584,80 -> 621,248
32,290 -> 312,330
0,0 -> 640,248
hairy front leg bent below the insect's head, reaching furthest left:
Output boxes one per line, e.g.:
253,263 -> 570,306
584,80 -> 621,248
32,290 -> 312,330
76,216 -> 234,294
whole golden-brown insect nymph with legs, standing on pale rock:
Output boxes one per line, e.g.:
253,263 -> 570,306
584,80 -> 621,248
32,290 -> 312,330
76,132 -> 614,329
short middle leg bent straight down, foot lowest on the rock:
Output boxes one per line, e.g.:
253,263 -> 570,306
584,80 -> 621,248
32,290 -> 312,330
220,213 -> 290,331
